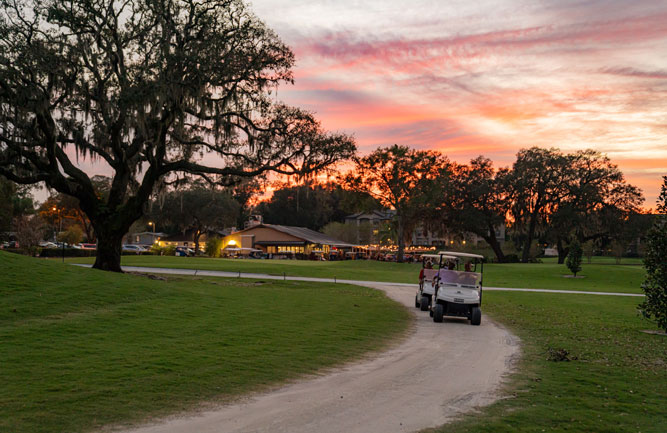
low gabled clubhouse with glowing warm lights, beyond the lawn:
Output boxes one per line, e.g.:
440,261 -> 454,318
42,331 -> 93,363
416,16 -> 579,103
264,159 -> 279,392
222,224 -> 354,258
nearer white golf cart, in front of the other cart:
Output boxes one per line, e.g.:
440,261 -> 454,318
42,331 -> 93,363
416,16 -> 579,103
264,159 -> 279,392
431,251 -> 484,325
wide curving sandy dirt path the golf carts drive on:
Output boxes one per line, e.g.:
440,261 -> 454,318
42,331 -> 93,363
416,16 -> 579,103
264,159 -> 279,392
117,284 -> 519,433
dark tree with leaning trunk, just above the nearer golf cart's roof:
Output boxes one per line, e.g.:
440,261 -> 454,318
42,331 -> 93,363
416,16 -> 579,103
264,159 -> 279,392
442,156 -> 510,262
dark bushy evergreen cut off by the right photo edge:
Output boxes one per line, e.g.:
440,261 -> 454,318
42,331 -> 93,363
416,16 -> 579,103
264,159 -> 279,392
639,176 -> 667,332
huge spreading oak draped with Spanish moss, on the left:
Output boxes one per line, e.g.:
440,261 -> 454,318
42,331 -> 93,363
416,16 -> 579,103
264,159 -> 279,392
0,0 -> 355,272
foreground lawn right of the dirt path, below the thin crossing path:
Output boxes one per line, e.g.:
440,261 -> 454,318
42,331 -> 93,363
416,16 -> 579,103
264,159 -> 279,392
434,292 -> 667,433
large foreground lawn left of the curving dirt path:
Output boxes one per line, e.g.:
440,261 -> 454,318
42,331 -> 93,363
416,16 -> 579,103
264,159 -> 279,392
0,252 -> 410,432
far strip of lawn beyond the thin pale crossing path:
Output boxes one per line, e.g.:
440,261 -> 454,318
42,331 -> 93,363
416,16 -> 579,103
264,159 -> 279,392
69,256 -> 644,293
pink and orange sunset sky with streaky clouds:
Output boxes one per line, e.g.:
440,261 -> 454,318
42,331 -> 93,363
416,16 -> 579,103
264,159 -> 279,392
251,0 -> 667,208
